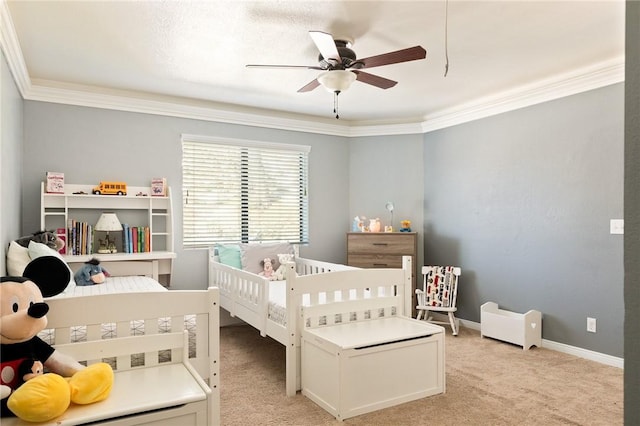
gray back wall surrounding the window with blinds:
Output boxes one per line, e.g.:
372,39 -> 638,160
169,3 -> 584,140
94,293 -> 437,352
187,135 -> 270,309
22,101 -> 349,289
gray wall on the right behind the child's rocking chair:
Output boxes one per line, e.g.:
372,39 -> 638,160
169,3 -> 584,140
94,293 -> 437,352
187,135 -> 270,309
424,84 -> 624,357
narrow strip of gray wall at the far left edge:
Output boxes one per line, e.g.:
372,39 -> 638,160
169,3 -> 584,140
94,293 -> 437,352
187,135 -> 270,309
0,48 -> 23,275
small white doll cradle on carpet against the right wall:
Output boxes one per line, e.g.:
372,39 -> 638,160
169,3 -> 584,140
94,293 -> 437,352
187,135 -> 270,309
480,302 -> 542,350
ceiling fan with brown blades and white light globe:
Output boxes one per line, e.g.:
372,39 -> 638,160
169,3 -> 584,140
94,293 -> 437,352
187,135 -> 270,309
247,31 -> 427,118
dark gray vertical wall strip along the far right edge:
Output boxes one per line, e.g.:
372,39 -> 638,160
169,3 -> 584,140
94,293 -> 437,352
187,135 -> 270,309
624,0 -> 640,425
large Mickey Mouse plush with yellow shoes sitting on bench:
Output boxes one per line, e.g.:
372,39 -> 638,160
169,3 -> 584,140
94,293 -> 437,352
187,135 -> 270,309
0,256 -> 113,422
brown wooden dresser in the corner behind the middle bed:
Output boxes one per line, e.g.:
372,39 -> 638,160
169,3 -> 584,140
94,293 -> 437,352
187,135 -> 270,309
347,232 -> 418,315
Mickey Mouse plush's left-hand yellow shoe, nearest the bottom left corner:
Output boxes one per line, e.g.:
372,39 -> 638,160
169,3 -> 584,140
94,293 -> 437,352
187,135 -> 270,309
7,373 -> 70,422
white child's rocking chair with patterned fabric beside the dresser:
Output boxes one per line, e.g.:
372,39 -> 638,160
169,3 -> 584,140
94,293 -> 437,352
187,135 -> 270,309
416,266 -> 462,336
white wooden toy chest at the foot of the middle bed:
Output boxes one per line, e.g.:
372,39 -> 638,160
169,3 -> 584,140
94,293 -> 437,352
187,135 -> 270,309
301,316 -> 445,420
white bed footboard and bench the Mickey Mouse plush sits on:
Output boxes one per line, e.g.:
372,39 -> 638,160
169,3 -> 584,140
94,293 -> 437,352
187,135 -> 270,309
2,288 -> 220,426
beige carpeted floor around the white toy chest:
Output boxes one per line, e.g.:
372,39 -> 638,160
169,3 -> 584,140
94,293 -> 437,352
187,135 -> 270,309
220,326 -> 623,426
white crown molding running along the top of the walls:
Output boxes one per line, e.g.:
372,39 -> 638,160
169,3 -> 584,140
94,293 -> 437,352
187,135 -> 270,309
0,0 -> 624,137
